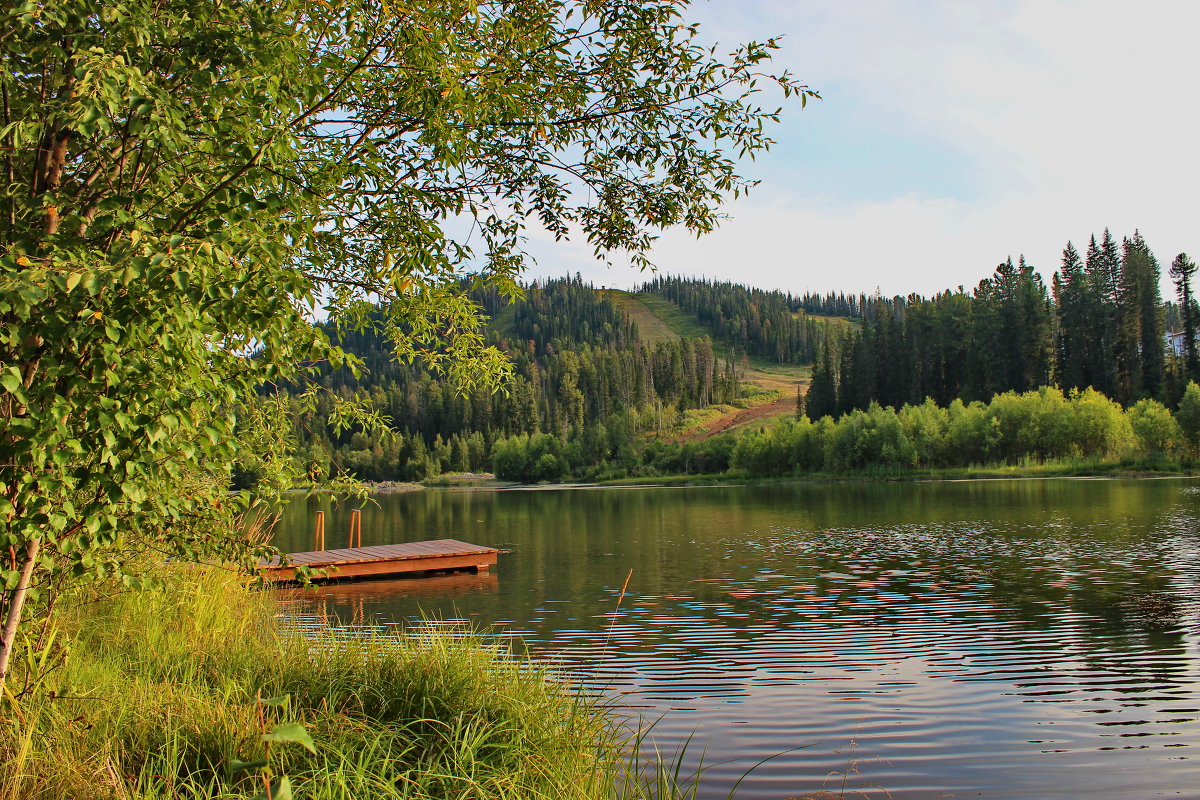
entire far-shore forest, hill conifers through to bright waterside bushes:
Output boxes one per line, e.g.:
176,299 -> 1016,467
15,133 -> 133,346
267,230 -> 1200,483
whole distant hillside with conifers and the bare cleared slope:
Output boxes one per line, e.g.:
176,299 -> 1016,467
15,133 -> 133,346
274,276 -> 842,482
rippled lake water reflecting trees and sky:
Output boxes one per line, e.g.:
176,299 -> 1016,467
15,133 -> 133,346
276,480 -> 1200,800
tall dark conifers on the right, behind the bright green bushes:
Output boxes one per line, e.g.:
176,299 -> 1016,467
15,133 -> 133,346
806,230 -> 1200,419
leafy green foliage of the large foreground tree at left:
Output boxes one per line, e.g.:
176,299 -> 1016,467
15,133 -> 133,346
0,0 -> 811,690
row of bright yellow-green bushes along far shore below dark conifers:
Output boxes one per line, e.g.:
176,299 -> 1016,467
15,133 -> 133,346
731,383 -> 1200,475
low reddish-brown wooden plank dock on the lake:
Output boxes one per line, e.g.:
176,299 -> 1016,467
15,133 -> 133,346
258,539 -> 498,583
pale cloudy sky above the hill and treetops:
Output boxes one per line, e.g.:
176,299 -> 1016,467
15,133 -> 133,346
520,0 -> 1200,296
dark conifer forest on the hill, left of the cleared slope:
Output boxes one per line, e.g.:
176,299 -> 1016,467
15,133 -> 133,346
277,277 -> 758,480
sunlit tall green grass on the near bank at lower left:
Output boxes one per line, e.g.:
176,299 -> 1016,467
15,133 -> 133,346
0,570 -> 696,800
